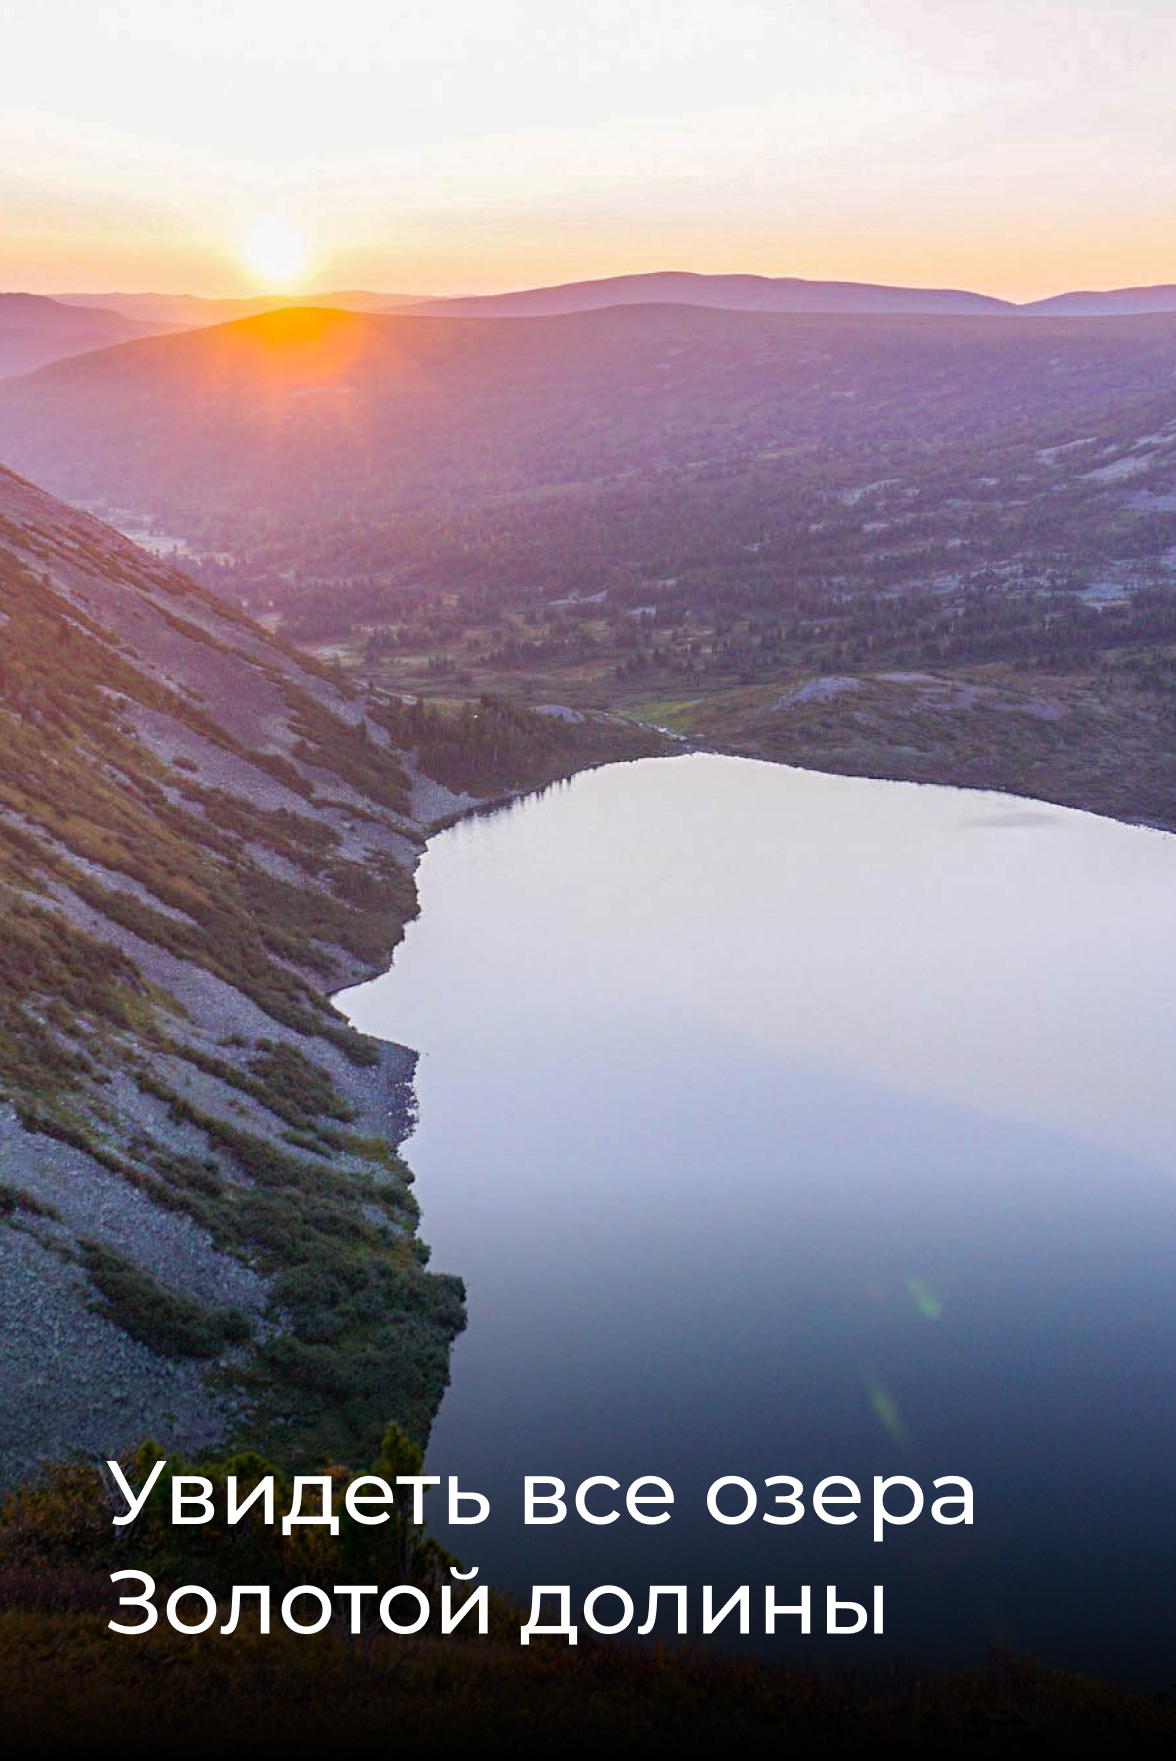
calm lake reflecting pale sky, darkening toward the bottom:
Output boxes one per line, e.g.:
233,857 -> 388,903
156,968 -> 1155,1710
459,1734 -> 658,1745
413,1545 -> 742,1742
340,755 -> 1176,1691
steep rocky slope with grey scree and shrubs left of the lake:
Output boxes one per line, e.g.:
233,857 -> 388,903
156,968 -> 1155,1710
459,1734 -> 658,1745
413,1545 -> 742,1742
0,470 -> 478,1483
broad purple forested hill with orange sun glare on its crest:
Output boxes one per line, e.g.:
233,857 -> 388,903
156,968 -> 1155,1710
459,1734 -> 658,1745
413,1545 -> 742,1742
0,305 -> 1176,609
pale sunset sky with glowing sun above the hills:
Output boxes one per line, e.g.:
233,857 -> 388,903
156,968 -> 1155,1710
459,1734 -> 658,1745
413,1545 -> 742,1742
0,0 -> 1176,298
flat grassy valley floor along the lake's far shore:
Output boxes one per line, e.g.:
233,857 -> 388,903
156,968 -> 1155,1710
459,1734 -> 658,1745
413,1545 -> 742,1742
323,643 -> 1176,831
